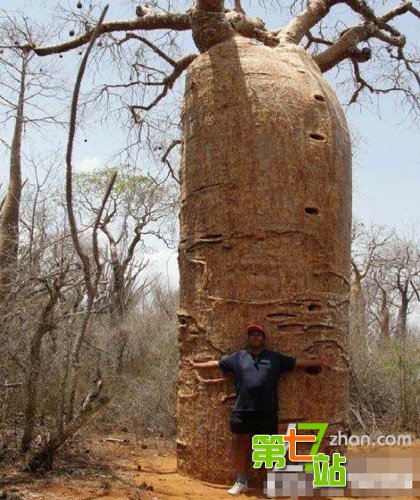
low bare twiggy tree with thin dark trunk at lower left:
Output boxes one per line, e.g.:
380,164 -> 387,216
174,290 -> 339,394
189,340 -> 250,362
2,158 -> 83,453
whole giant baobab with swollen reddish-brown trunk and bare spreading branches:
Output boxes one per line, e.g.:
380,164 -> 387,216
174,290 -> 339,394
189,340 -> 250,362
8,0 -> 420,482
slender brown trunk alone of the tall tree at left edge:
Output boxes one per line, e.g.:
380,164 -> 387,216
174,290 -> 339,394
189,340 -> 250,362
0,56 -> 27,305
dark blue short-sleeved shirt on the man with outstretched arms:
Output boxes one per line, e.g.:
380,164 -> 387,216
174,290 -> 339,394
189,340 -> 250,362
219,349 -> 296,412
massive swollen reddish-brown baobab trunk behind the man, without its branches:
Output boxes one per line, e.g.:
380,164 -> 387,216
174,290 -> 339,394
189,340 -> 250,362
176,37 -> 351,483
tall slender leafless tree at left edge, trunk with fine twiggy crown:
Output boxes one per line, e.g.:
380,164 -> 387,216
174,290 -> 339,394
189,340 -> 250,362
0,10 -> 65,303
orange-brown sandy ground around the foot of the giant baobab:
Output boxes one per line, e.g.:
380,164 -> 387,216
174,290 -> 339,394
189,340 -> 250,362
0,434 -> 420,500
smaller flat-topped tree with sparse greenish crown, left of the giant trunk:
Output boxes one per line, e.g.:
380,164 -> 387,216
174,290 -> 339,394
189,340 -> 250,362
75,165 -> 175,374
